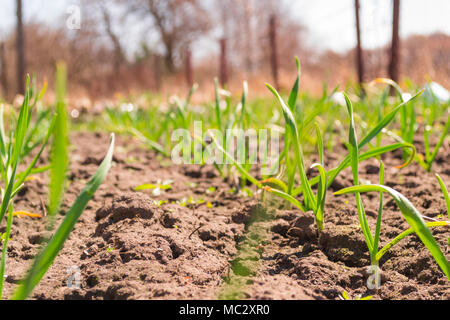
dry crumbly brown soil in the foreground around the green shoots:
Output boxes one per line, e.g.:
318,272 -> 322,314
0,132 -> 450,300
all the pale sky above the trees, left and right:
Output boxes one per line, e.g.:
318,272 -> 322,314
0,0 -> 450,52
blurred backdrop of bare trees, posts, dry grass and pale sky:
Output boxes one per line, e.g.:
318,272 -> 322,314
0,0 -> 450,100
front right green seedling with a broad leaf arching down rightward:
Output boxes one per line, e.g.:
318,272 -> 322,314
335,96 -> 450,280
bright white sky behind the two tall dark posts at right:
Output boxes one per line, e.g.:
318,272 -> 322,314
294,0 -> 450,51
